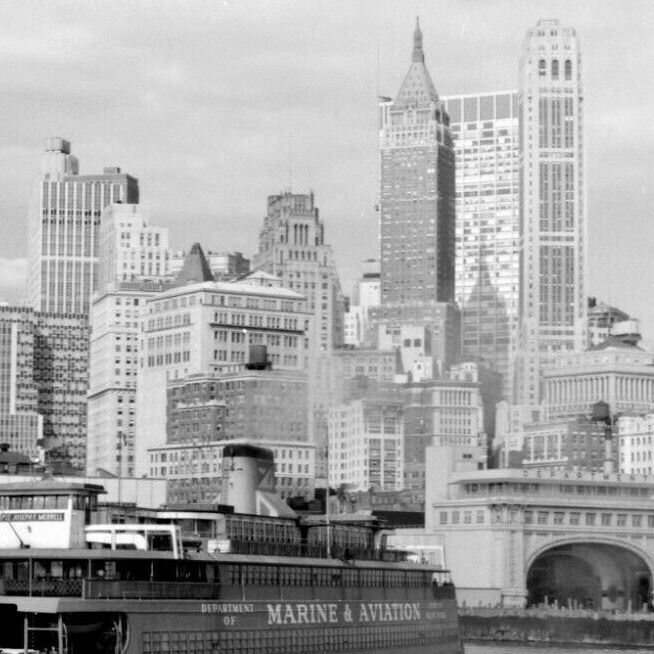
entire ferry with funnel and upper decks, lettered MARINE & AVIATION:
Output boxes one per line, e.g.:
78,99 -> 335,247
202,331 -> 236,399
0,444 -> 462,654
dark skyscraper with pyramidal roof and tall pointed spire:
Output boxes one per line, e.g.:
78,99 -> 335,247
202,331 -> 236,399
379,20 -> 455,311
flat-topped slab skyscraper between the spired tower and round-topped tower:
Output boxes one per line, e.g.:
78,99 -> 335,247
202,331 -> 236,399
443,91 -> 520,399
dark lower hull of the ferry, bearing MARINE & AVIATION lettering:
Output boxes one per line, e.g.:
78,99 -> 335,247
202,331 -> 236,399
0,597 -> 462,654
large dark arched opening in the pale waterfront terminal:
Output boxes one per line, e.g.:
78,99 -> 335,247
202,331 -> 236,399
527,542 -> 652,611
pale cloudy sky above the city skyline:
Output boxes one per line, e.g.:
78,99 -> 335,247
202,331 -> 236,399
0,0 -> 654,340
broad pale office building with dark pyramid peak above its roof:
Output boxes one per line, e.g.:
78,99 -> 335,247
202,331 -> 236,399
135,244 -> 309,476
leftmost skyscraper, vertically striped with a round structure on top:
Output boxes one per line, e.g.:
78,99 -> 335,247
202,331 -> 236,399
28,138 -> 139,315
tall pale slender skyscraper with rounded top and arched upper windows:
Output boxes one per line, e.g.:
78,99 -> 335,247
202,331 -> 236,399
516,20 -> 586,406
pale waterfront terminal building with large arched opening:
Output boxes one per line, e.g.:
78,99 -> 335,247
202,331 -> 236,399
425,466 -> 654,611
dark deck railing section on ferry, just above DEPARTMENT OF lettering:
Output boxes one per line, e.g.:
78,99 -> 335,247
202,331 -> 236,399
82,579 -> 220,600
